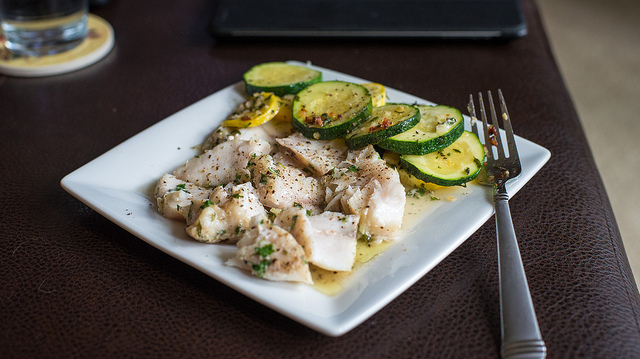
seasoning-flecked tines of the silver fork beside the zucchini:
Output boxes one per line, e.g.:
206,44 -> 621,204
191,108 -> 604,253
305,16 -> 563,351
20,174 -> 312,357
468,89 -> 520,176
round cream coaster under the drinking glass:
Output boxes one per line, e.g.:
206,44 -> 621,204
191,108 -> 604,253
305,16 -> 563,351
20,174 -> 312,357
0,14 -> 115,77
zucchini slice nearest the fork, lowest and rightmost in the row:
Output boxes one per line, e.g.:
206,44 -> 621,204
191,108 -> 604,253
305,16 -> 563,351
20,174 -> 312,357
400,131 -> 485,186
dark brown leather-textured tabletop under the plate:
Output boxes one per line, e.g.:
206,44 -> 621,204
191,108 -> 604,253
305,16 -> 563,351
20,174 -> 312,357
0,0 -> 640,358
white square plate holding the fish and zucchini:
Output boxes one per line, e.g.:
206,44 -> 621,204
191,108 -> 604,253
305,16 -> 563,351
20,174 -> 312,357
61,62 -> 550,336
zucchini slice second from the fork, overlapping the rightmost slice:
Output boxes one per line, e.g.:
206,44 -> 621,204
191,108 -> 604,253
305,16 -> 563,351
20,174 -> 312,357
378,105 -> 464,155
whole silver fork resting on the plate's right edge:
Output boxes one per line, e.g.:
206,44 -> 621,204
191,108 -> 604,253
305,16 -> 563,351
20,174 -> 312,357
468,90 -> 547,358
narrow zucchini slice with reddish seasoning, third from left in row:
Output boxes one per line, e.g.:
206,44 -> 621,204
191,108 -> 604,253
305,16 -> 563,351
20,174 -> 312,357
344,103 -> 420,150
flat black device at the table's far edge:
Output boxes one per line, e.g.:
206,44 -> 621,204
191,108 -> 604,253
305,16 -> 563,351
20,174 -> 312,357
211,0 -> 527,39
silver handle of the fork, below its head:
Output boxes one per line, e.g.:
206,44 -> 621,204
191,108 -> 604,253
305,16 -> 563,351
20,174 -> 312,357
494,186 -> 547,358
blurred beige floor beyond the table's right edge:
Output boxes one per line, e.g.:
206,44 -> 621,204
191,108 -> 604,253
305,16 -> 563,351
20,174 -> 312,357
537,0 -> 640,284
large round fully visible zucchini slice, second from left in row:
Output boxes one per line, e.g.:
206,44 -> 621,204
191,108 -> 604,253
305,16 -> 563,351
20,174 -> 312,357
291,81 -> 373,140
